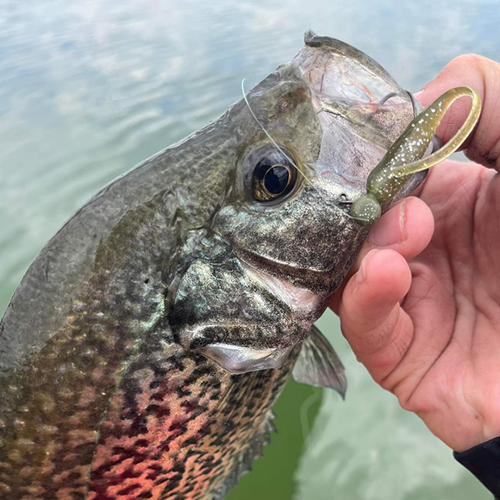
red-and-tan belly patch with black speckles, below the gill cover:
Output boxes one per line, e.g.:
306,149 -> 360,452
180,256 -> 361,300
88,352 -> 292,500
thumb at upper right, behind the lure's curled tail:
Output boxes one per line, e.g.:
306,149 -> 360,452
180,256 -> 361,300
415,54 -> 500,170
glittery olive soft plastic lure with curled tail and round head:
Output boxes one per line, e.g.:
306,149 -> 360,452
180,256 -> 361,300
351,87 -> 481,225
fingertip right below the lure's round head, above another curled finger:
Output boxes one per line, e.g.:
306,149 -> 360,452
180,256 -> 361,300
330,197 -> 434,314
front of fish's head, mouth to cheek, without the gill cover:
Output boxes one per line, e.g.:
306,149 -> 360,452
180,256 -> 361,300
215,32 -> 422,295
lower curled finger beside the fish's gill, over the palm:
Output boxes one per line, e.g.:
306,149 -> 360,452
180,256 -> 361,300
339,250 -> 413,383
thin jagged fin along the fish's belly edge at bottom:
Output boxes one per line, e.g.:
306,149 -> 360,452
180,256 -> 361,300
210,410 -> 276,500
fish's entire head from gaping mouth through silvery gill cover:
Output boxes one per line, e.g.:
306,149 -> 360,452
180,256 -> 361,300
176,32 -> 423,373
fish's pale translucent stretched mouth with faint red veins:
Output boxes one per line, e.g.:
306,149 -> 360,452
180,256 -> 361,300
294,31 -> 413,150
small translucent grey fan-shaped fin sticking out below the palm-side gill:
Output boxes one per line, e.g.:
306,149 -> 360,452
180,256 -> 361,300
292,325 -> 347,399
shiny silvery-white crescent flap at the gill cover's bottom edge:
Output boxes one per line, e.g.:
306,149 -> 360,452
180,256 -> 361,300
199,343 -> 294,375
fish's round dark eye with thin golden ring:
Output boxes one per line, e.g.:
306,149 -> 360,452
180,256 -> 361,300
251,151 -> 297,202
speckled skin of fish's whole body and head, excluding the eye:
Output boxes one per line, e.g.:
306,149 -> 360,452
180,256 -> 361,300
0,33 -> 422,500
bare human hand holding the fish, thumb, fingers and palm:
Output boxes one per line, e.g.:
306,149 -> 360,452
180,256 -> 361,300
331,55 -> 500,451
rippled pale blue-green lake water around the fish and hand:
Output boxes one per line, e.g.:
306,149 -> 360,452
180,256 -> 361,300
0,0 -> 500,500
